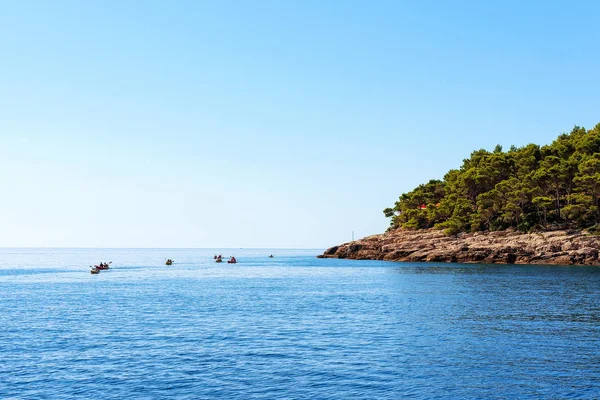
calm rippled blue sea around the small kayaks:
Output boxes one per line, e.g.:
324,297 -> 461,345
0,249 -> 600,399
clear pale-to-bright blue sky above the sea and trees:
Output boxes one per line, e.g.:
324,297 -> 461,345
0,0 -> 600,248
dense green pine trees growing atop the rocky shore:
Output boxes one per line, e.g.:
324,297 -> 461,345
383,124 -> 600,235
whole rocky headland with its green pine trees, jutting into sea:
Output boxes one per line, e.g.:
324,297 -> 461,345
319,124 -> 600,265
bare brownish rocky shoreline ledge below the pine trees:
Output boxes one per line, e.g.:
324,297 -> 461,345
319,229 -> 600,265
